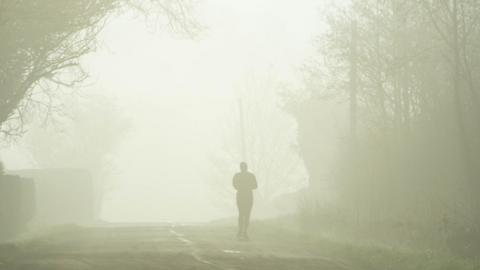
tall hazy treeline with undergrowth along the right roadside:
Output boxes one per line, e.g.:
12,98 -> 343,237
293,0 -> 480,255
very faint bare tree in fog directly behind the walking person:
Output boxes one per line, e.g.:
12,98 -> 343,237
211,72 -> 308,213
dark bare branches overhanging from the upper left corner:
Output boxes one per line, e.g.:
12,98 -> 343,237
0,0 -> 198,139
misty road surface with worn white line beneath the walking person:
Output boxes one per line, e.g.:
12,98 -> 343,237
0,224 -> 353,270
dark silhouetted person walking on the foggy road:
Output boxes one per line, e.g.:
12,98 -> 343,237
233,162 -> 257,240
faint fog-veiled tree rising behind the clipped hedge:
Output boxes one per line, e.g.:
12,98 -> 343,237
25,95 -> 129,215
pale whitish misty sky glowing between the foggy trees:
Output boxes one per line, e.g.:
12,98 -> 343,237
4,0 -> 328,221
